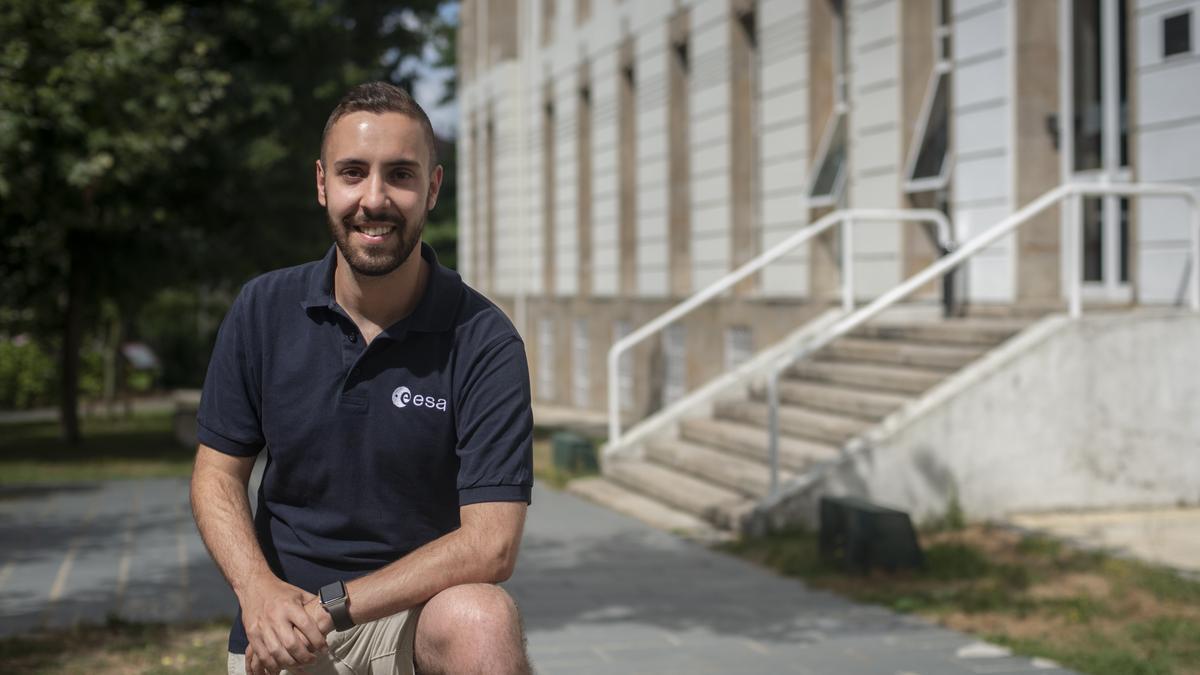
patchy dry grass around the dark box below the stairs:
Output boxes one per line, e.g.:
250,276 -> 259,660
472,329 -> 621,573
724,526 -> 1200,675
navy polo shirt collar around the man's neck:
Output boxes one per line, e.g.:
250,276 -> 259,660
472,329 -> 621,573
301,241 -> 462,333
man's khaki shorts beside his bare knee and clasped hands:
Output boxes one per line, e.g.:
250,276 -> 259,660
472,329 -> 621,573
229,608 -> 421,675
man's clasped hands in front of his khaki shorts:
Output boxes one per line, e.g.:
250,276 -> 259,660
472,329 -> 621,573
238,577 -> 332,675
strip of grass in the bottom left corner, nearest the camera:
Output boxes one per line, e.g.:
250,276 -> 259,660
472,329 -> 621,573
0,620 -> 229,675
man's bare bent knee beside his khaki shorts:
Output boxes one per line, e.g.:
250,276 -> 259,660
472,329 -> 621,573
414,584 -> 530,675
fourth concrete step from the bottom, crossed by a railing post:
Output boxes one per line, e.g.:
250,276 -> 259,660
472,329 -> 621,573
679,417 -> 839,473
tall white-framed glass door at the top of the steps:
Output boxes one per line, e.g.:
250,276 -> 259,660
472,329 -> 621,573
1060,0 -> 1132,301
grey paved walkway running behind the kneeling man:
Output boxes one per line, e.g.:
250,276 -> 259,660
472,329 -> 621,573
0,479 -> 1064,675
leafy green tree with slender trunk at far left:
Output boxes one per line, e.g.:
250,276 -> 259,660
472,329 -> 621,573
0,0 -> 229,442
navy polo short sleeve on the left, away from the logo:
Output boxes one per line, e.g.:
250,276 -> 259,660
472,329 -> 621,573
196,288 -> 265,456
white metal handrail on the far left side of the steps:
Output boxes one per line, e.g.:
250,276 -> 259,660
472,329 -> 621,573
606,209 -> 954,452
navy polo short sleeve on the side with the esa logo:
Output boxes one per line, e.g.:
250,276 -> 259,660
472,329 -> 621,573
455,336 -> 533,506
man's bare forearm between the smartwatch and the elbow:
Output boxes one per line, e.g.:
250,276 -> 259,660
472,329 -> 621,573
347,502 -> 526,623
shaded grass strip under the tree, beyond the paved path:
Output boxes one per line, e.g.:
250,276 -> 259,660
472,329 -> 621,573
0,413 -> 194,484
